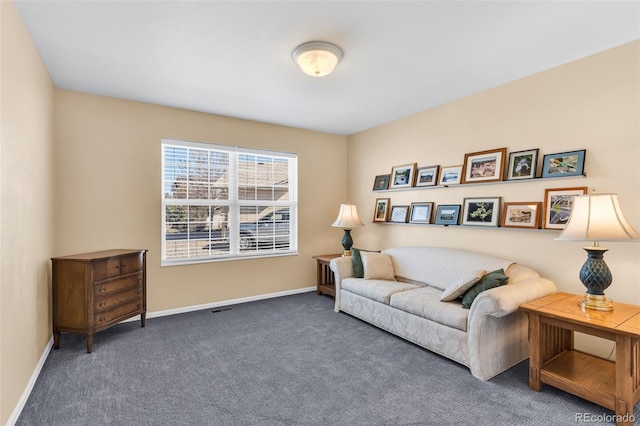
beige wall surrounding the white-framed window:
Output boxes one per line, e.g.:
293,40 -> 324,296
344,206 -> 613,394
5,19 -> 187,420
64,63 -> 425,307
55,90 -> 346,312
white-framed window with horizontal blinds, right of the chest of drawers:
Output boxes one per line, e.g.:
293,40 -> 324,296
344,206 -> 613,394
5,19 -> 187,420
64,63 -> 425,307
162,139 -> 298,265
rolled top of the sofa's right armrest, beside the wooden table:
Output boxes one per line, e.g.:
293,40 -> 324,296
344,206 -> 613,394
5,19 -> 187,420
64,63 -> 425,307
469,278 -> 557,321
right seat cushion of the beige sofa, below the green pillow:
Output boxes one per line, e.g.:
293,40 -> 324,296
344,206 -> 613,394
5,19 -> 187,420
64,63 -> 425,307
389,287 -> 469,331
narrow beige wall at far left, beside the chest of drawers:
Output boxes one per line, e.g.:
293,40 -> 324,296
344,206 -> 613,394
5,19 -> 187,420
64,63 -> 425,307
0,1 -> 54,424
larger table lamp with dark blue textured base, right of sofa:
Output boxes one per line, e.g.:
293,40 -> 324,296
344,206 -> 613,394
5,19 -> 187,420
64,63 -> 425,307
556,194 -> 640,311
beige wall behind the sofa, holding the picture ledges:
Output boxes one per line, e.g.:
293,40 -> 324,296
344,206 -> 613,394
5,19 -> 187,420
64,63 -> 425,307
348,41 -> 640,355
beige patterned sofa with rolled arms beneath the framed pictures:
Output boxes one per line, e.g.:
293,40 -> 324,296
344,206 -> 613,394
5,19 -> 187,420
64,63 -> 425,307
330,247 -> 556,380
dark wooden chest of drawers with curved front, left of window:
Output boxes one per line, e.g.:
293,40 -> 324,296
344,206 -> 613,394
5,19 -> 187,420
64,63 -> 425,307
51,249 -> 147,353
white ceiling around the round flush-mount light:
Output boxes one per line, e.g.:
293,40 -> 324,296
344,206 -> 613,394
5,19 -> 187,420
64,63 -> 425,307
15,0 -> 640,135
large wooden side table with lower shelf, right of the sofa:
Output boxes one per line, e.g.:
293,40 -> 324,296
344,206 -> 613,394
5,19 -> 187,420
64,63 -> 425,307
520,293 -> 640,425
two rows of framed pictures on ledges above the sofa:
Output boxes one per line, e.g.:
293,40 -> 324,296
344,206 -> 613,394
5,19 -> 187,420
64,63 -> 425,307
373,148 -> 587,230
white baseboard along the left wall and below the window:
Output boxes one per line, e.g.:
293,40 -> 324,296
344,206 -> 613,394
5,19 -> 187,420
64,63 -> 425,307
7,286 -> 316,426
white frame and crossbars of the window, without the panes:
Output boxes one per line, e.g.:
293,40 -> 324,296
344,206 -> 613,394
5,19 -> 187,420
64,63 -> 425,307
161,138 -> 298,266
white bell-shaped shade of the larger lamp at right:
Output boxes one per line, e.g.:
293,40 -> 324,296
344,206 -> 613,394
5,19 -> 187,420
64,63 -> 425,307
556,194 -> 640,241
